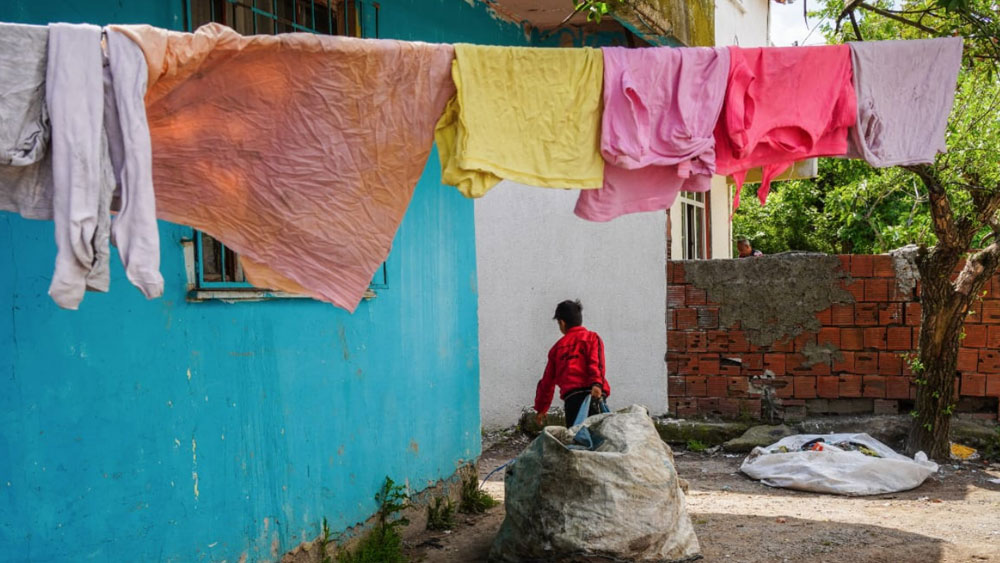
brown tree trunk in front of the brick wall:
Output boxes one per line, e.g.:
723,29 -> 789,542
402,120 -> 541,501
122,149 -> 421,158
906,249 -> 970,460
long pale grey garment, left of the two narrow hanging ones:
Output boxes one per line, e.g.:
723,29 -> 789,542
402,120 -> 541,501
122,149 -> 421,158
45,24 -> 114,309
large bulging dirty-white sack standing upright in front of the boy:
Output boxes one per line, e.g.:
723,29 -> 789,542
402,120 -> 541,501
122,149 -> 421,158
490,405 -> 700,562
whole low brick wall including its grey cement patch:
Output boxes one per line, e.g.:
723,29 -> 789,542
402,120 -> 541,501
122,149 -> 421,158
667,254 -> 1000,419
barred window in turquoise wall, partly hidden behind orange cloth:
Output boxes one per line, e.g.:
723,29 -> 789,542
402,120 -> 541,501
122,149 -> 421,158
185,0 -> 387,300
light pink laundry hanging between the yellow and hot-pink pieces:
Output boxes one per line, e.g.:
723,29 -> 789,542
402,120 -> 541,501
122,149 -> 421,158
575,47 -> 729,221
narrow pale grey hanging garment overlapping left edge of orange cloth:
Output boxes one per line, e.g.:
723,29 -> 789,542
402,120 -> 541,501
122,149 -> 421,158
104,29 -> 163,299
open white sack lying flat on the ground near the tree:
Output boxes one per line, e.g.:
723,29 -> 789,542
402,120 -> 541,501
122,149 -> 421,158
740,434 -> 938,496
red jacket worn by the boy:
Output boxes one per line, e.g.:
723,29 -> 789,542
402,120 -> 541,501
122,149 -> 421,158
535,326 -> 611,413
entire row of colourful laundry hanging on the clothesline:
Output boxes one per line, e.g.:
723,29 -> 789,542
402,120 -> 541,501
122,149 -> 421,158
0,20 -> 962,311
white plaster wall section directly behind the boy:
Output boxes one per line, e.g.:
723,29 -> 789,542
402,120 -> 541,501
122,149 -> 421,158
475,182 -> 667,429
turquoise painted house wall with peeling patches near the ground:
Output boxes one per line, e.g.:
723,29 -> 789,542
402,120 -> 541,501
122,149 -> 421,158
0,0 -> 564,562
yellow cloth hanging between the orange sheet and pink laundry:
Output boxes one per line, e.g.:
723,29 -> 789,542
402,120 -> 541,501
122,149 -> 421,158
435,44 -> 604,197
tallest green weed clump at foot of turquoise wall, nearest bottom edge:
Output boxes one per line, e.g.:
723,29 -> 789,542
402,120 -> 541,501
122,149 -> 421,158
336,477 -> 410,563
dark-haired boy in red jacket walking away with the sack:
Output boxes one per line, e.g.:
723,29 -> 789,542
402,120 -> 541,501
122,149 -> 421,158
535,301 -> 611,427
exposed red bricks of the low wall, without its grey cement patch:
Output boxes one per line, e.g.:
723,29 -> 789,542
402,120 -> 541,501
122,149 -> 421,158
667,255 -> 1000,418
